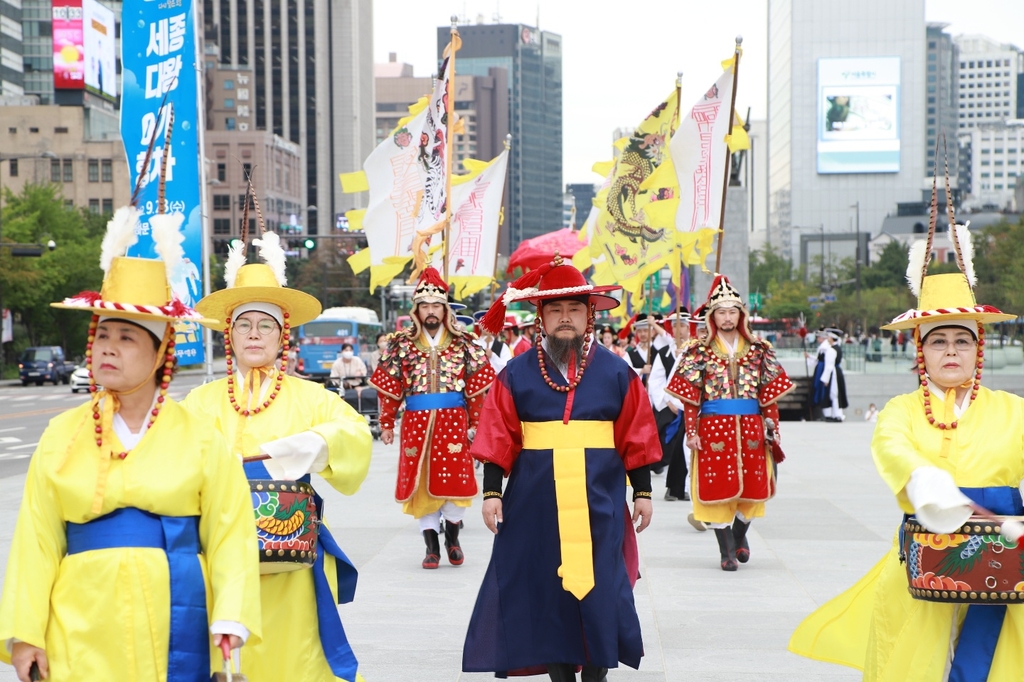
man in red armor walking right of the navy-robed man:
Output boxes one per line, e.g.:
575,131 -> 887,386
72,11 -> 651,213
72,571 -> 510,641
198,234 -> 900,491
666,274 -> 793,571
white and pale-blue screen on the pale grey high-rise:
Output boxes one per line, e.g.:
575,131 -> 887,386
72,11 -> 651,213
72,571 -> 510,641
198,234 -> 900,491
817,57 -> 900,173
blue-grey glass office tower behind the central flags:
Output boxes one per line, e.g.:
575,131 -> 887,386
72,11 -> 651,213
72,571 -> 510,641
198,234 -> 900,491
437,24 -> 563,253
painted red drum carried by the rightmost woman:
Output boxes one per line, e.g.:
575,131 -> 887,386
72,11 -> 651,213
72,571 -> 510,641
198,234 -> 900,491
901,516 -> 1024,604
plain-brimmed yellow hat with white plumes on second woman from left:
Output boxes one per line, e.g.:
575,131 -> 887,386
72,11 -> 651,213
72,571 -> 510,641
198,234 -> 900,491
196,232 -> 324,332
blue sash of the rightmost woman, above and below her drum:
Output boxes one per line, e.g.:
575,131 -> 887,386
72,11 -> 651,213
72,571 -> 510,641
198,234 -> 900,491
949,486 -> 1024,682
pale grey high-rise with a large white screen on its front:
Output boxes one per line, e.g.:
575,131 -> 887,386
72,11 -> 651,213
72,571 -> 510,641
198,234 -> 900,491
766,0 -> 938,260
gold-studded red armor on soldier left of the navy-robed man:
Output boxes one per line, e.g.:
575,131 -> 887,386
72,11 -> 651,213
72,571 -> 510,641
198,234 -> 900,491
370,333 -> 495,502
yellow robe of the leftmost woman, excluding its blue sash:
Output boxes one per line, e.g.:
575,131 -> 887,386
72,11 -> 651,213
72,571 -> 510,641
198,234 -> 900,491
0,399 -> 260,682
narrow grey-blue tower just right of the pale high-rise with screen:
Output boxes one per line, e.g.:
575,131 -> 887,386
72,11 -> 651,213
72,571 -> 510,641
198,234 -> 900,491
925,23 -> 961,175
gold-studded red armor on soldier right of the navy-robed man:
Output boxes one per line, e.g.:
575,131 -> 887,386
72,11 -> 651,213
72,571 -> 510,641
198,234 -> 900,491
666,339 -> 794,504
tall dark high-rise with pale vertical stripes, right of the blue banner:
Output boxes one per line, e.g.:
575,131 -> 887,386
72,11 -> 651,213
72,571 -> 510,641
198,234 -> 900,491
201,0 -> 374,235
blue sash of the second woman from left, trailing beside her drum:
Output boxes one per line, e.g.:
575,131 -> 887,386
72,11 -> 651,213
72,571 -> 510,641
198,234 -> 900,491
243,458 -> 360,681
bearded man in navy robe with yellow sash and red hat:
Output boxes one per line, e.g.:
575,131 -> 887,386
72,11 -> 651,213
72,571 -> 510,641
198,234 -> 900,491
463,258 -> 660,682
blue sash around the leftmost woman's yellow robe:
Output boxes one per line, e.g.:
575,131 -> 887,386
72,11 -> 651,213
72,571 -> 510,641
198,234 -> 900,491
68,507 -> 210,682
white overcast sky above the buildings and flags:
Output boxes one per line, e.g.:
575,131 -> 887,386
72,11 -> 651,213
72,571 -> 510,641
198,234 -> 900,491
374,0 -> 1024,182
